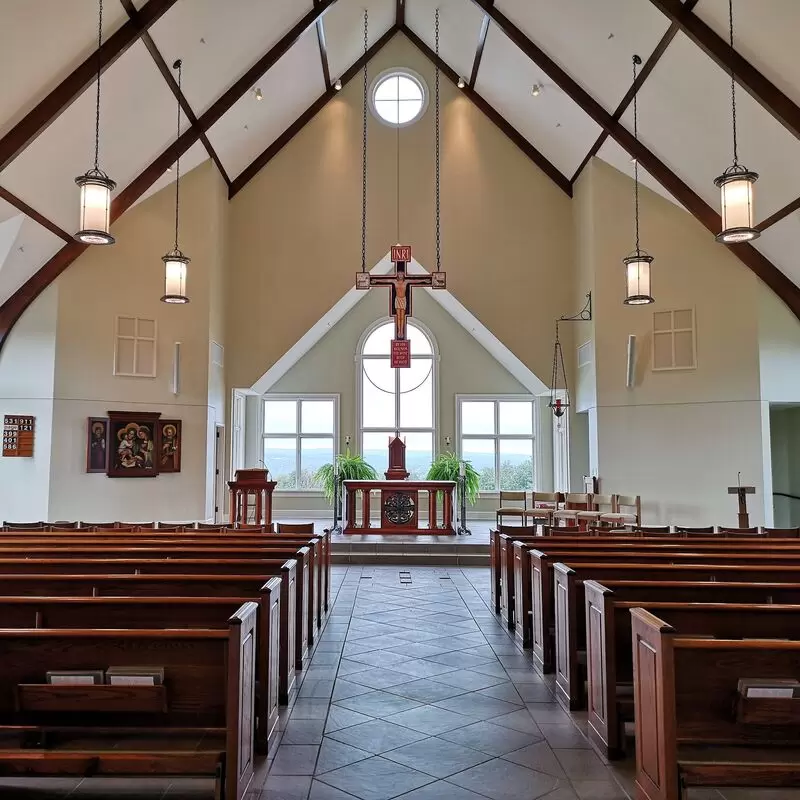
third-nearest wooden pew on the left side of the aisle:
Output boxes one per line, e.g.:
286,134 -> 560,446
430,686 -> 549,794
0,560 -> 300,702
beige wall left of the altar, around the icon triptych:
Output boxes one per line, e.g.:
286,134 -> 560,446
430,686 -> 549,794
43,162 -> 227,521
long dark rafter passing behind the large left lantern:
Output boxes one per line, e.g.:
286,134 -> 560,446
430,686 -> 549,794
0,0 -> 336,351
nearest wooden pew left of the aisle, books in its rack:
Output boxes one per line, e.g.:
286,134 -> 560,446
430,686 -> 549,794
0,603 -> 257,800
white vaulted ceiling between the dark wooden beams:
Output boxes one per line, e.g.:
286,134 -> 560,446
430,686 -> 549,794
0,0 -> 800,302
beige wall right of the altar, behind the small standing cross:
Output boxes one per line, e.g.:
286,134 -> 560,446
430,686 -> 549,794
576,159 -> 772,524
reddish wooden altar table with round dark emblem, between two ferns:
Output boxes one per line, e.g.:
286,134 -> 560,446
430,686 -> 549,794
343,480 -> 456,535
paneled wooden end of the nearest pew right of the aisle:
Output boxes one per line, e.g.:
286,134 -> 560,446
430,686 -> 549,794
631,608 -> 680,800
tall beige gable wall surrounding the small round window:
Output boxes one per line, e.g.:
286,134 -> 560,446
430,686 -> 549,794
228,36 -> 572,394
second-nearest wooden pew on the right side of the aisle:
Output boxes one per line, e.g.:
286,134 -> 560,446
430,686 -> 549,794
584,581 -> 800,758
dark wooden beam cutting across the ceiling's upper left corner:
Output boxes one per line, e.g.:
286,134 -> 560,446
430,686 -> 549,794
0,0 -> 177,171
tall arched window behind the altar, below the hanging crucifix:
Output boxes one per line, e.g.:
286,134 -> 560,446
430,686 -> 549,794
358,320 -> 437,480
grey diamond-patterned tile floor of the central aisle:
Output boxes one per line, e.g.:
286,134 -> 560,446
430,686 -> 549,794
0,566 -> 800,800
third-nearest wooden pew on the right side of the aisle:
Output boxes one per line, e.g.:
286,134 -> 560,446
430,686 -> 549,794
552,554 -> 800,710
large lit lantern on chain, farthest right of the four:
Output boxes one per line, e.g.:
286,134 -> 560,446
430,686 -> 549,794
714,0 -> 761,244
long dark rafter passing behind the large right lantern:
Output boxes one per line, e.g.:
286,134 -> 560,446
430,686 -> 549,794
472,0 -> 800,319
